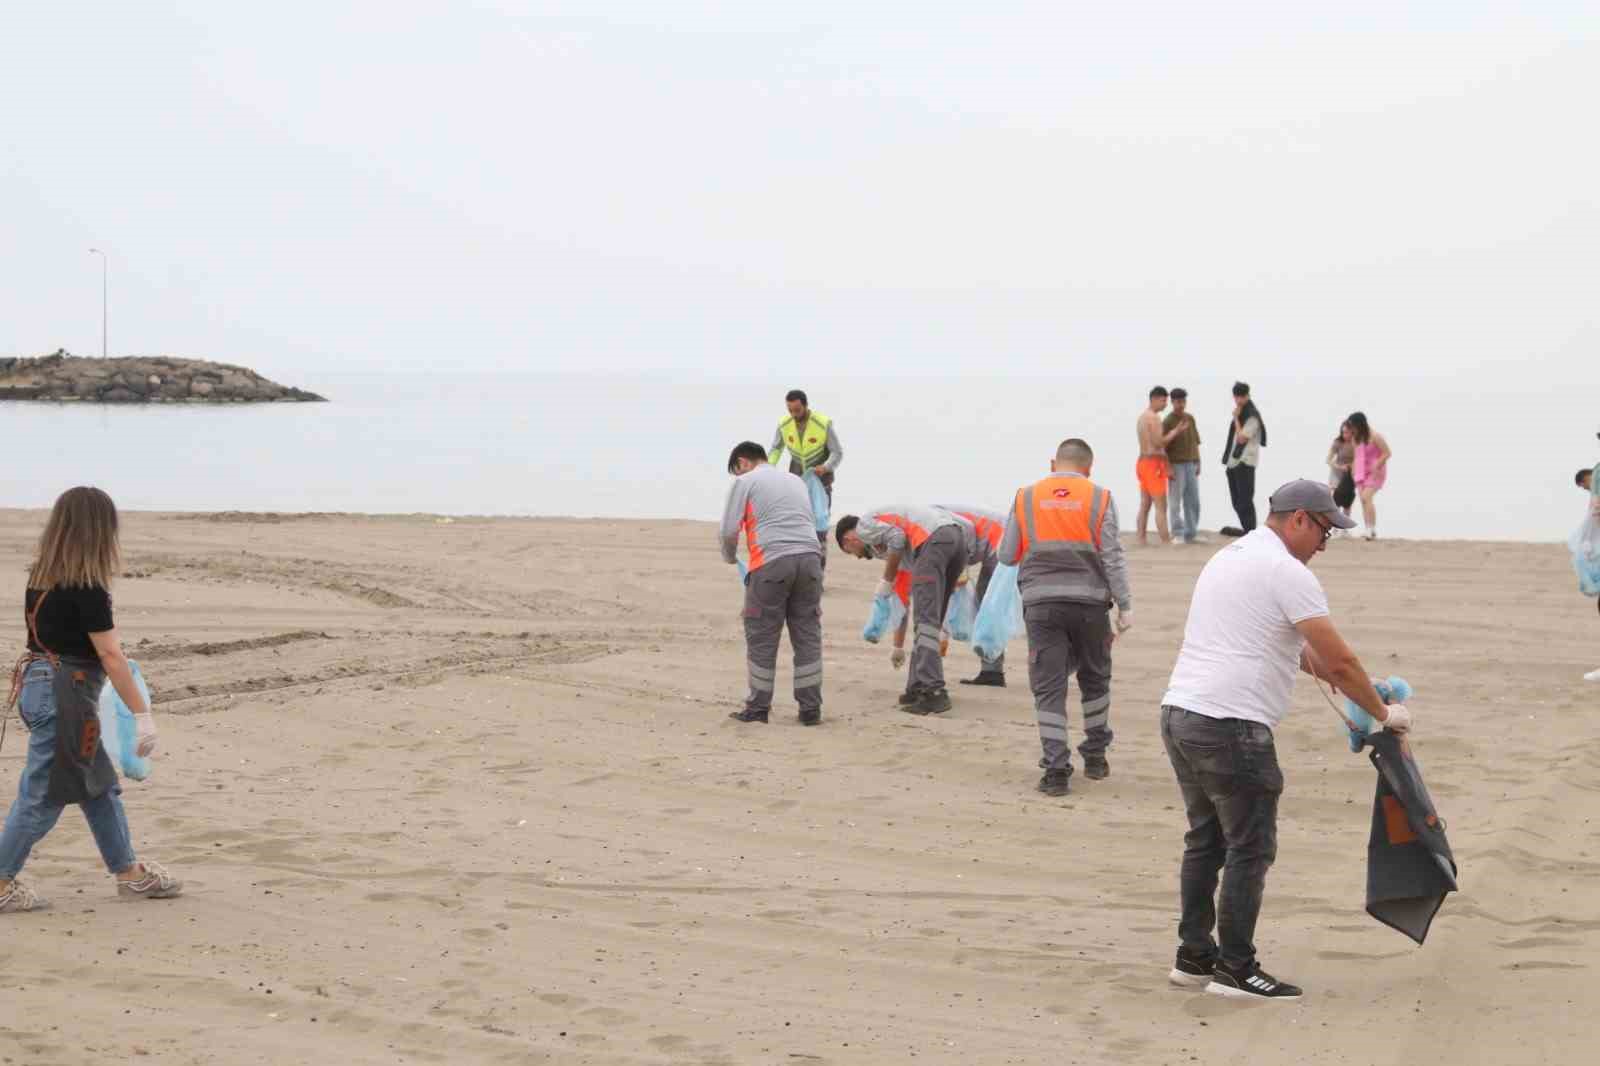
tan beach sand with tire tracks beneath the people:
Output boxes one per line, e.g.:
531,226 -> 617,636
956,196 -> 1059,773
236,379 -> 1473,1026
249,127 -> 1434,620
0,511 -> 1600,1066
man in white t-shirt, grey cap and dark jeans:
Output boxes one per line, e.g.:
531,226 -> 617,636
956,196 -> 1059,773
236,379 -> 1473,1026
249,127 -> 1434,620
1162,480 -> 1411,999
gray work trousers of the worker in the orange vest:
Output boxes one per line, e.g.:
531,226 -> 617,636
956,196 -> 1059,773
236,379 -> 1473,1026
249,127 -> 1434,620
1022,600 -> 1110,773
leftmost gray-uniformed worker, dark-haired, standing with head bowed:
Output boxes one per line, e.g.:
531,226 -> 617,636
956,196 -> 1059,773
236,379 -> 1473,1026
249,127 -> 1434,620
717,440 -> 822,725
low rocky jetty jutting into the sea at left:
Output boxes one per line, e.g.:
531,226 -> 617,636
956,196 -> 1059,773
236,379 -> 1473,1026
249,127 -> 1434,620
0,351 -> 323,403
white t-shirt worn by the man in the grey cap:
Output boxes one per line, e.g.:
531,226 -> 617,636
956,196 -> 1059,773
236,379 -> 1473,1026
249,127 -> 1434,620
1162,528 -> 1328,728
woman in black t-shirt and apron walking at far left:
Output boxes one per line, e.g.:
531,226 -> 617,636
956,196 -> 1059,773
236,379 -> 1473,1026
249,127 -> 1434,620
0,488 -> 182,914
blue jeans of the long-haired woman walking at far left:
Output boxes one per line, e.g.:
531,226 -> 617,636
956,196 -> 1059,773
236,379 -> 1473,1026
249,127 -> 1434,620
0,661 -> 138,880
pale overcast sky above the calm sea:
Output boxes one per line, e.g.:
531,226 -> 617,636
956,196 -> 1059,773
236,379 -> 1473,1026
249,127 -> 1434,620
0,0 -> 1600,381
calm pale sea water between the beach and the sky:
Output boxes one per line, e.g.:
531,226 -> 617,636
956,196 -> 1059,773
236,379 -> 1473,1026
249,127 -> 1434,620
0,373 -> 1600,541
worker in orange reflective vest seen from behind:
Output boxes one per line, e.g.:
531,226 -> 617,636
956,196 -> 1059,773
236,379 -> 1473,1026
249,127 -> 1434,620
1000,437 -> 1133,795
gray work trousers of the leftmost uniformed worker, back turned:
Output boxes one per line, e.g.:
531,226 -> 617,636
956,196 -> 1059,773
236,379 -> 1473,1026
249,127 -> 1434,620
744,554 -> 822,711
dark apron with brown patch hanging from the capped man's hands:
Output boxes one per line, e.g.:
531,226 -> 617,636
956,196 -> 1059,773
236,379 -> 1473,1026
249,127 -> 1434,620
1365,731 -> 1456,944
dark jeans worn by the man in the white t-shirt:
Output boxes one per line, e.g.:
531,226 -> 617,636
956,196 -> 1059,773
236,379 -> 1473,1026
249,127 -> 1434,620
1162,707 -> 1283,968
